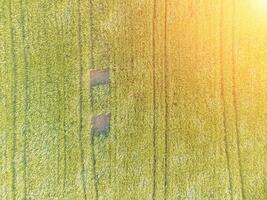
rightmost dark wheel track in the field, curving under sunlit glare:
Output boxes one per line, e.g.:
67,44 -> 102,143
232,0 -> 245,199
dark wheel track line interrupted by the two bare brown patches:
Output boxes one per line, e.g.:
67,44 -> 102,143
89,0 -> 98,200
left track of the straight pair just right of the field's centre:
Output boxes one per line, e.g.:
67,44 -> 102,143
152,0 -> 157,199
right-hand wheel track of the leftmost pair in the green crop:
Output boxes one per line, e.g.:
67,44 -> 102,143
20,0 -> 30,199
